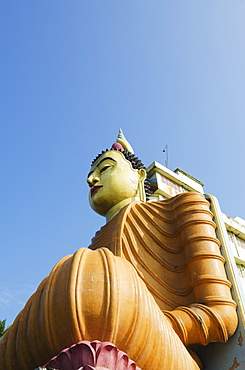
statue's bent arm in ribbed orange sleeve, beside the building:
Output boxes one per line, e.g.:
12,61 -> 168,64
164,208 -> 237,345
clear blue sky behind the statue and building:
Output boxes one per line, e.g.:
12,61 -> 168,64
0,0 -> 245,324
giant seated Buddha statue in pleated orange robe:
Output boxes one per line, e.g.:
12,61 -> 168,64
0,131 -> 237,370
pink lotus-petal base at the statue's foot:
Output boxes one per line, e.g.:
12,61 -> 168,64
44,340 -> 140,370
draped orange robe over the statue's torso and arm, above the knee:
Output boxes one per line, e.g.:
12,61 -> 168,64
89,192 -> 237,345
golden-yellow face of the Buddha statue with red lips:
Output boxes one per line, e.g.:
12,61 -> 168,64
87,150 -> 145,216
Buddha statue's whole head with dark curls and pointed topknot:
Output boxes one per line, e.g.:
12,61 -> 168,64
87,131 -> 149,221
